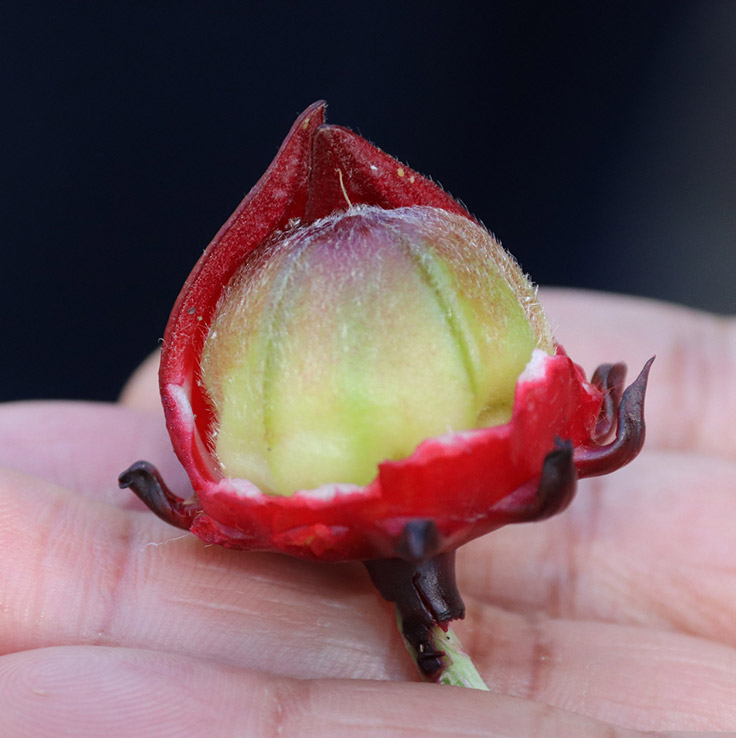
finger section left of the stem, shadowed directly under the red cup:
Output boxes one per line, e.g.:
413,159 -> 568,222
0,470 -> 402,679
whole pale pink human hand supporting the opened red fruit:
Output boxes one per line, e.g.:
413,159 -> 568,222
0,290 -> 736,738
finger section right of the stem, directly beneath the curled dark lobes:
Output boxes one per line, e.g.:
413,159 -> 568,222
458,442 -> 736,647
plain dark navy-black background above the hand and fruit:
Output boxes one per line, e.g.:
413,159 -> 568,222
0,0 -> 736,400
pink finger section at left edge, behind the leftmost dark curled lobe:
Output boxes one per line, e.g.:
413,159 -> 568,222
0,402 -> 190,507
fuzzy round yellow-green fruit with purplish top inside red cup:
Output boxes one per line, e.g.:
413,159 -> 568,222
201,201 -> 554,495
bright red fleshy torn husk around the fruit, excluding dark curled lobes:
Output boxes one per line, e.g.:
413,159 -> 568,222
160,102 -> 602,561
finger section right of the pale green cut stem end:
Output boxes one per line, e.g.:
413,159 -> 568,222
456,601 -> 736,731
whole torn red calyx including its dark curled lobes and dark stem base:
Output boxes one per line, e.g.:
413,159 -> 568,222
120,102 -> 651,675
